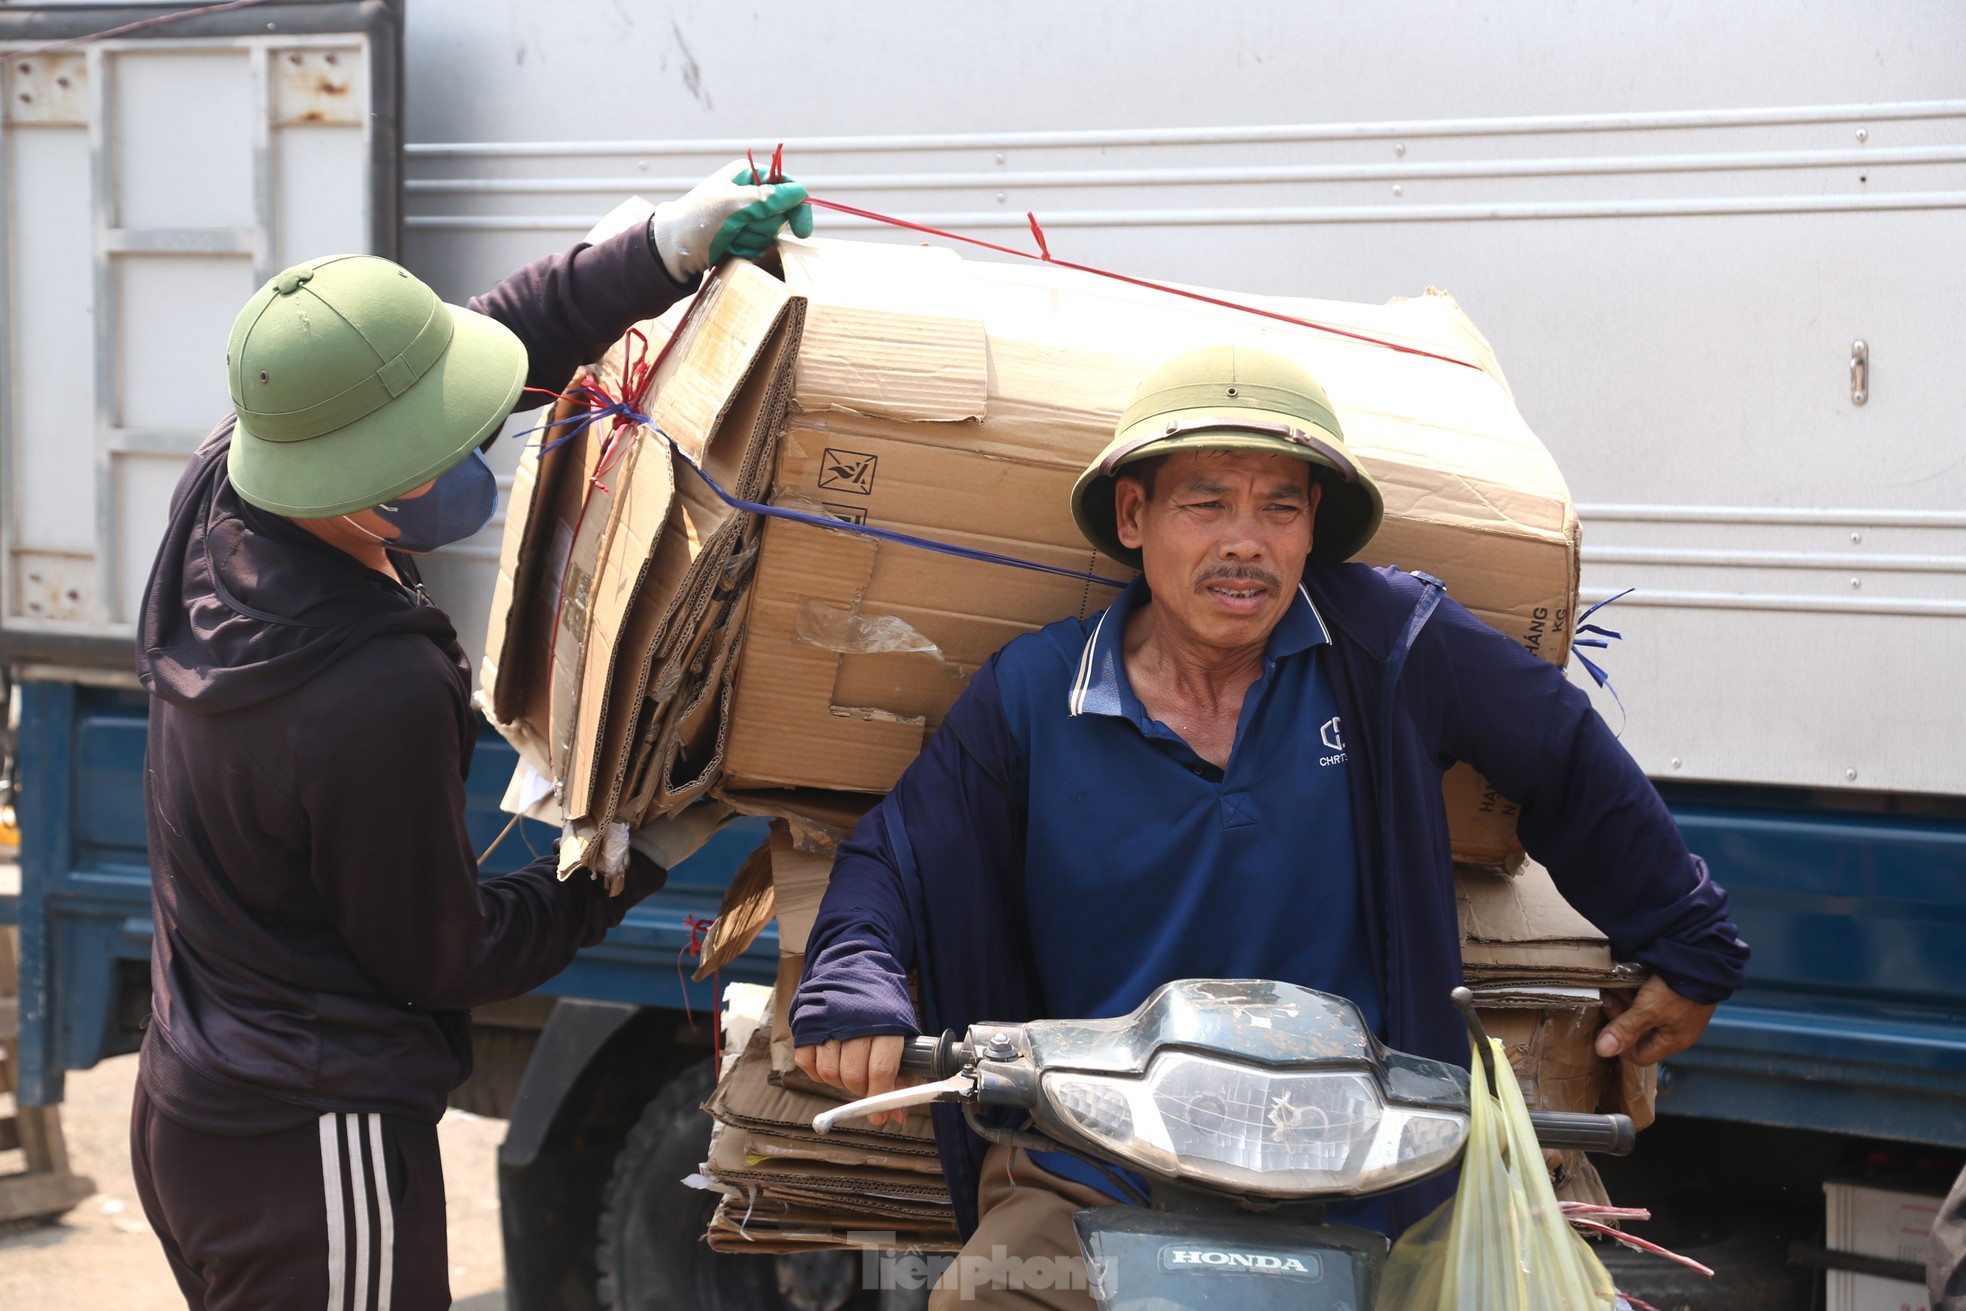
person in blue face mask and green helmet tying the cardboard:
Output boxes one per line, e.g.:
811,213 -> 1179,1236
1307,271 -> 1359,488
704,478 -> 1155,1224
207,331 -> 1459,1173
130,165 -> 812,1311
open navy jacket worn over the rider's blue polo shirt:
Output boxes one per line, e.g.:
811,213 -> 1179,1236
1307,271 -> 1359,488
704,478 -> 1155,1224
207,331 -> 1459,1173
792,564 -> 1748,1234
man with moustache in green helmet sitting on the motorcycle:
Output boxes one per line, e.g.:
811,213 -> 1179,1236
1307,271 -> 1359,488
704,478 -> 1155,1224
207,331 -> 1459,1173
792,346 -> 1748,1311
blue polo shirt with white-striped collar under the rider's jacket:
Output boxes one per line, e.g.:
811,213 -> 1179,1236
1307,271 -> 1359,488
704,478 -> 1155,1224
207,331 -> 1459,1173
997,578 -> 1382,1218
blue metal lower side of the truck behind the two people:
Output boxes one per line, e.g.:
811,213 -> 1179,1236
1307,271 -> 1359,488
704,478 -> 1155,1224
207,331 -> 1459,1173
0,682 -> 1966,1146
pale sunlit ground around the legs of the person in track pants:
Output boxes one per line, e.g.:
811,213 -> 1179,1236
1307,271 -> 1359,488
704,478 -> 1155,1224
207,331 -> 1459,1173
0,1055 -> 505,1311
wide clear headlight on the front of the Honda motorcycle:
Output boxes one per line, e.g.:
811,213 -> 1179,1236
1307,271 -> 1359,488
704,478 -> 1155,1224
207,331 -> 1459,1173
1044,1052 -> 1467,1197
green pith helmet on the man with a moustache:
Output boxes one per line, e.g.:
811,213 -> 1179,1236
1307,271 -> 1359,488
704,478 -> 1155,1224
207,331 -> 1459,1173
1071,346 -> 1386,568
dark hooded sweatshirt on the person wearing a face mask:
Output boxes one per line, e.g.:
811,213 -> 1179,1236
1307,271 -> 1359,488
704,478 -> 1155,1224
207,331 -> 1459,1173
138,228 -> 688,1134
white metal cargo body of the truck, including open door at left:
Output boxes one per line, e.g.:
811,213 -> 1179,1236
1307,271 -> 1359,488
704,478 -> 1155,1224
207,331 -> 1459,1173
0,0 -> 1966,792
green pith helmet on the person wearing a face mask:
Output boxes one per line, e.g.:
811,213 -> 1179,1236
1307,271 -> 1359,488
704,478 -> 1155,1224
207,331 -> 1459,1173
226,256 -> 527,519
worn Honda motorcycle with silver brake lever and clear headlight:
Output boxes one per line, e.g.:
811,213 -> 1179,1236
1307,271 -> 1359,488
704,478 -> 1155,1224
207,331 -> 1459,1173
812,979 -> 1636,1311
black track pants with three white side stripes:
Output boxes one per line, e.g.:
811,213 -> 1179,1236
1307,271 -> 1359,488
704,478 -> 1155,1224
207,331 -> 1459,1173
130,1081 -> 450,1311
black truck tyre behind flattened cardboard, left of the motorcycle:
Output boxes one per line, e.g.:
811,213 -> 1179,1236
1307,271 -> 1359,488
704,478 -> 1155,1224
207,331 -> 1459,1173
596,1061 -> 873,1311
